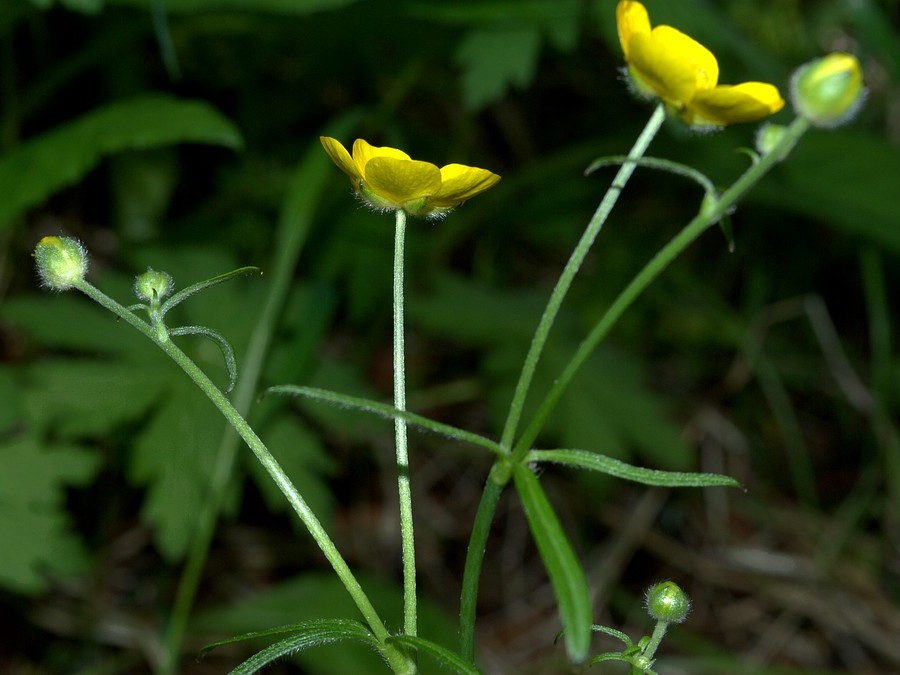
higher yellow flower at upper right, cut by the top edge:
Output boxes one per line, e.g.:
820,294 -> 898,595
616,0 -> 784,126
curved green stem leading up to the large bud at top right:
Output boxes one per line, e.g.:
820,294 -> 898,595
513,117 -> 809,462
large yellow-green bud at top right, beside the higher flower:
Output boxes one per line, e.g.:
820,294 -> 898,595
791,52 -> 866,127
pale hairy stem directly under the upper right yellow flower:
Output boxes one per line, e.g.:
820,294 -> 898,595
500,104 -> 666,448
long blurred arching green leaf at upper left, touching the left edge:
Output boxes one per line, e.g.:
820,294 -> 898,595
0,94 -> 242,231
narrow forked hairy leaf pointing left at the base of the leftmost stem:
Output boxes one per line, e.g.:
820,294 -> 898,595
198,619 -> 381,675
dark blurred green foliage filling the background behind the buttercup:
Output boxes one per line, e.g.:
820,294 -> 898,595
0,0 -> 900,673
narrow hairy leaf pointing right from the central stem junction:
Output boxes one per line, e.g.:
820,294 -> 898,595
526,450 -> 741,488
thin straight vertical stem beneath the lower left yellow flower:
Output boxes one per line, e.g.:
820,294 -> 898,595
393,209 -> 417,636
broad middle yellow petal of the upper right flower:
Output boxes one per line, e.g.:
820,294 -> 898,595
630,26 -> 719,108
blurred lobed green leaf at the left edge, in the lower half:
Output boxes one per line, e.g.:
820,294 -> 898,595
0,435 -> 99,593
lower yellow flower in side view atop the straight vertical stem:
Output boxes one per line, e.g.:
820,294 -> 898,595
319,136 -> 500,216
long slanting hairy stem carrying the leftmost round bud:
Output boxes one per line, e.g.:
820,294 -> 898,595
75,281 -> 414,673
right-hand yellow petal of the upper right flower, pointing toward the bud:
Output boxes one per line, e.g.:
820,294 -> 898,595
686,82 -> 784,125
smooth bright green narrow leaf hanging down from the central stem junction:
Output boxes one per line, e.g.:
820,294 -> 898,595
513,464 -> 592,663
